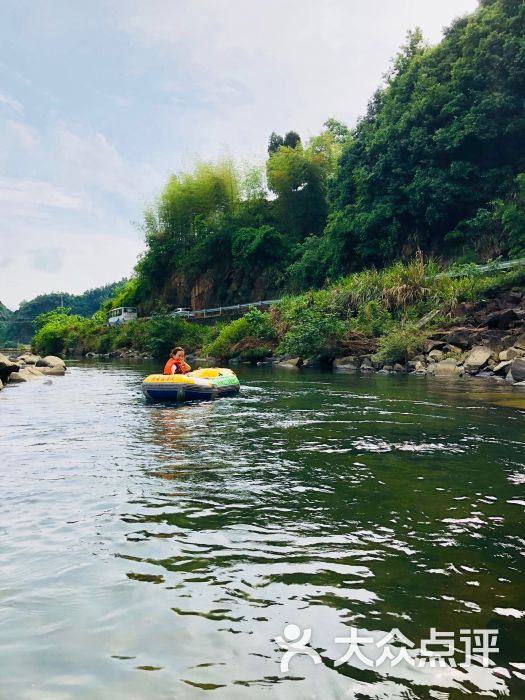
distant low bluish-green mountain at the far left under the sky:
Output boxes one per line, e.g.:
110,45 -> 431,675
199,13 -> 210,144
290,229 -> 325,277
0,280 -> 124,345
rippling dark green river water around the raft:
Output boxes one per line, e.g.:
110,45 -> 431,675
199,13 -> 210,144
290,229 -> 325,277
0,363 -> 525,700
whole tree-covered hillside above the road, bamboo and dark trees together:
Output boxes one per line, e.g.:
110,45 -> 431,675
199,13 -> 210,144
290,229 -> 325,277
109,0 -> 525,311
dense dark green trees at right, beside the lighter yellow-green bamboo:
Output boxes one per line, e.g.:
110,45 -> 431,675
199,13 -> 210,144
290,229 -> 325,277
320,0 -> 525,272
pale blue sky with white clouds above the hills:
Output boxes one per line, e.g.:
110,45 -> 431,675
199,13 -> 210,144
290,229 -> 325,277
0,0 -> 477,309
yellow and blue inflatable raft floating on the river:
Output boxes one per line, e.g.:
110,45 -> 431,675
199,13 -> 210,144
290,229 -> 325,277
142,367 -> 240,401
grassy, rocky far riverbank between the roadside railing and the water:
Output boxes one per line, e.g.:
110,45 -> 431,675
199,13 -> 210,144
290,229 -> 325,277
29,259 -> 525,383
